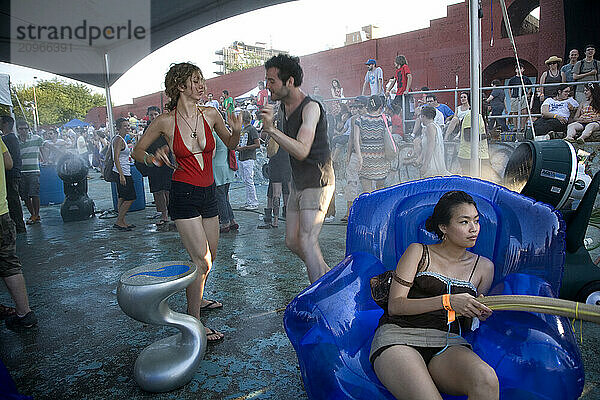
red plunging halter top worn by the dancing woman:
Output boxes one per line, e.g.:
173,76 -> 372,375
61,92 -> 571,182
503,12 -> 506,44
172,111 -> 215,187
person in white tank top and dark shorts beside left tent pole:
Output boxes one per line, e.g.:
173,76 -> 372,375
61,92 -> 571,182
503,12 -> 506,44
112,118 -> 136,231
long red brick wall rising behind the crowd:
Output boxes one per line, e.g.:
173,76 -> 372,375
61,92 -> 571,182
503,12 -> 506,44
86,0 -> 565,125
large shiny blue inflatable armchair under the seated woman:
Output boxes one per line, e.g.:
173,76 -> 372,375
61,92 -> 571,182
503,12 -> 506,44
284,176 -> 584,400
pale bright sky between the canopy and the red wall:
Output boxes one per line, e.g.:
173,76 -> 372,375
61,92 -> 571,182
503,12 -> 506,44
0,0 -> 462,105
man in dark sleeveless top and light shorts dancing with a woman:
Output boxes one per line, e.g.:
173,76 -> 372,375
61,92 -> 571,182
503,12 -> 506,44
260,54 -> 335,283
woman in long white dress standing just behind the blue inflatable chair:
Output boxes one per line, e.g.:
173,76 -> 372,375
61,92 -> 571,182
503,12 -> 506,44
417,106 -> 450,178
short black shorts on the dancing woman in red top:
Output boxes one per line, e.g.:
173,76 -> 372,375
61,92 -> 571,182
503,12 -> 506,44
169,181 -> 219,220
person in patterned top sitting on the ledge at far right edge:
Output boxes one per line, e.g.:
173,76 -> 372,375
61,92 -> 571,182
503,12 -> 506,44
565,83 -> 600,144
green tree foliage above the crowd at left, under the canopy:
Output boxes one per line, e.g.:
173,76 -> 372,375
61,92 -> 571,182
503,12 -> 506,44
11,79 -> 106,126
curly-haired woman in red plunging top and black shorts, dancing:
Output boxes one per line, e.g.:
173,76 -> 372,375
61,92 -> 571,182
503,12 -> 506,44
132,63 -> 242,342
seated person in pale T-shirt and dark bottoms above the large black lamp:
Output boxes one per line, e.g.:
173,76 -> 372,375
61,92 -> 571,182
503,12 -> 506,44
533,85 -> 579,139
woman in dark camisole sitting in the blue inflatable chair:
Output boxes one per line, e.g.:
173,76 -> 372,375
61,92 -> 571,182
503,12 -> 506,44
369,191 -> 499,400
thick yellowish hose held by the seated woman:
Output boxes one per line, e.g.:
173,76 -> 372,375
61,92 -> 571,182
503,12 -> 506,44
477,295 -> 600,324
